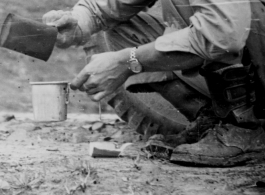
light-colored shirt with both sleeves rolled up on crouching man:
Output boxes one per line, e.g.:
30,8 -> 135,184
73,0 -> 251,63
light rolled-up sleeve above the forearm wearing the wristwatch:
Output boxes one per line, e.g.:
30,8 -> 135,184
156,0 -> 251,60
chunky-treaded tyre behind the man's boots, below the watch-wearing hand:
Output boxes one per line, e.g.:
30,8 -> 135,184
105,88 -> 187,140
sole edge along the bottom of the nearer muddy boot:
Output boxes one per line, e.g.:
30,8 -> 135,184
170,151 -> 265,167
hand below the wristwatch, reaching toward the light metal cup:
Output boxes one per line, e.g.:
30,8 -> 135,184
70,49 -> 132,101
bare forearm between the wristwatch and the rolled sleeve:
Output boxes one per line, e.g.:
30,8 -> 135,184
119,42 -> 204,72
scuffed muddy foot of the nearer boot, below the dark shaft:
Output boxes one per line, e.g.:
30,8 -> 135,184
170,125 -> 265,167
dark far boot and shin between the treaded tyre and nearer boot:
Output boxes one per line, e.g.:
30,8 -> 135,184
147,77 -> 219,147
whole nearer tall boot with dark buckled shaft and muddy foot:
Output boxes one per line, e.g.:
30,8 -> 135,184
170,65 -> 265,166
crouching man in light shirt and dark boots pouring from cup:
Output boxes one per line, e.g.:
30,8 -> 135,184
43,0 -> 265,166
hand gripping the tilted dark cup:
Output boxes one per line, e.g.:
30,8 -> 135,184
42,10 -> 82,48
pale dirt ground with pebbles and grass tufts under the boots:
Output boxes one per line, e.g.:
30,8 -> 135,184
0,113 -> 265,195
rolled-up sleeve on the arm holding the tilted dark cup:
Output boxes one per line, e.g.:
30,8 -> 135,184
72,0 -> 155,42
